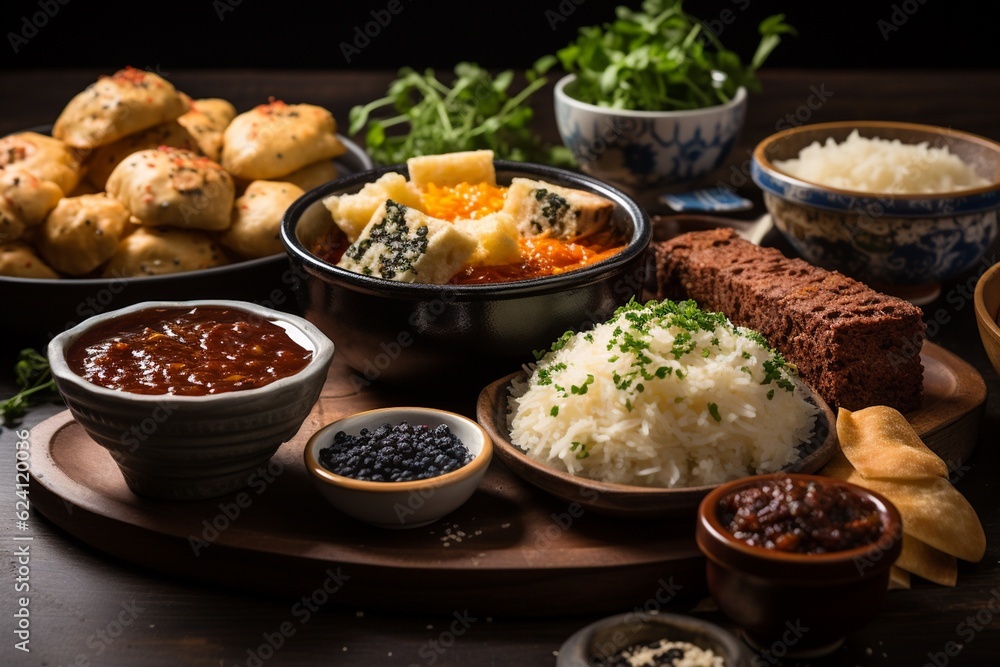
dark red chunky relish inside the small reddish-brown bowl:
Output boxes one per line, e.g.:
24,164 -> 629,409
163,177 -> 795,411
719,477 -> 882,554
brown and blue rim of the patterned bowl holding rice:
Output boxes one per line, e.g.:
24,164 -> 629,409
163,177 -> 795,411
753,120 -> 1000,202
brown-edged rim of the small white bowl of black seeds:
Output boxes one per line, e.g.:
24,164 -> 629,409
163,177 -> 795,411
302,406 -> 493,494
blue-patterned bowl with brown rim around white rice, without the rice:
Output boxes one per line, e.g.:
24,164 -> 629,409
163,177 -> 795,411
751,121 -> 1000,304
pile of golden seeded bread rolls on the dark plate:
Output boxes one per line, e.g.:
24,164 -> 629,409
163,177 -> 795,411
0,67 -> 346,278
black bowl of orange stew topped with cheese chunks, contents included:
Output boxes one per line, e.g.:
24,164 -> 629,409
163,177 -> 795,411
281,151 -> 651,396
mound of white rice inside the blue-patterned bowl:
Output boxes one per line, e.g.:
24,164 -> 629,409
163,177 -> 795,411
774,130 -> 989,194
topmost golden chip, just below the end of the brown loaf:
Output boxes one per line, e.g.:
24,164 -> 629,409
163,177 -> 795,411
837,405 -> 948,480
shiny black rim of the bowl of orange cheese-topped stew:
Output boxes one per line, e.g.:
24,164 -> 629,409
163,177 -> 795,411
281,160 -> 653,300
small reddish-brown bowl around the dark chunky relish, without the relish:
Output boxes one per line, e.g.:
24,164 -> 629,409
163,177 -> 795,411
695,474 -> 903,659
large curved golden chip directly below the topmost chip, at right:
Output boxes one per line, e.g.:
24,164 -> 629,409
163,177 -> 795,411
846,472 -> 986,562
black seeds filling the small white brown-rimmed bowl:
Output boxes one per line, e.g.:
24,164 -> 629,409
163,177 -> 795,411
319,421 -> 472,482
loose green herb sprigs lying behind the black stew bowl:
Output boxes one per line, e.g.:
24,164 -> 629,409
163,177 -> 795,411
350,56 -> 573,166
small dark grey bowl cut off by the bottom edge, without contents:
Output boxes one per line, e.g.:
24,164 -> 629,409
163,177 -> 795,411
556,611 -> 751,667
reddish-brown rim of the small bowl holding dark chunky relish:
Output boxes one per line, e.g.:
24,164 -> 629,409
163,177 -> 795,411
698,473 -> 903,572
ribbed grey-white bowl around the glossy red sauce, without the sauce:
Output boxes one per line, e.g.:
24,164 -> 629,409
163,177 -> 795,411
48,300 -> 333,500
